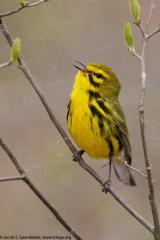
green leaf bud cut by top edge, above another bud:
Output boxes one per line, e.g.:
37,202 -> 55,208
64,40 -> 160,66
129,0 -> 141,24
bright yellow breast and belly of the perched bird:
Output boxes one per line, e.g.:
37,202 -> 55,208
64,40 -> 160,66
67,77 -> 119,158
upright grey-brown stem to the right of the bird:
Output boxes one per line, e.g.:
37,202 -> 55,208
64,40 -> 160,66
139,38 -> 160,240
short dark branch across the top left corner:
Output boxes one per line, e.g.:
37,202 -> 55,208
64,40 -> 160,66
0,0 -> 49,18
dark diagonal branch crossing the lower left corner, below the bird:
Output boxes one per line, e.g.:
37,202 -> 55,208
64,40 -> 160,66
0,138 -> 83,240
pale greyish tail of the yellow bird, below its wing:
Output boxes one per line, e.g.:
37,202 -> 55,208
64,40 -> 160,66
113,161 -> 136,186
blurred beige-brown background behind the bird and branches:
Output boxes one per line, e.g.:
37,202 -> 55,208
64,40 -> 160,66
0,0 -> 160,240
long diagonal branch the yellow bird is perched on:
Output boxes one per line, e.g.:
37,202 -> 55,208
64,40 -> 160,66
0,19 -> 153,233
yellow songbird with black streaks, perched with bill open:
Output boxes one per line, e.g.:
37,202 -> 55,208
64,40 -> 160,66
67,61 -> 136,186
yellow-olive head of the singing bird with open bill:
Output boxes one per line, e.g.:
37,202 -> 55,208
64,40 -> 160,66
74,61 -> 121,99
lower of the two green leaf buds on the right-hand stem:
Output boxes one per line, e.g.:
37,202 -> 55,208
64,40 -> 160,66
124,22 -> 135,53
